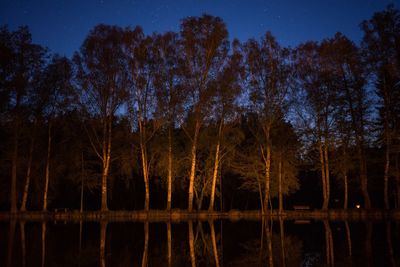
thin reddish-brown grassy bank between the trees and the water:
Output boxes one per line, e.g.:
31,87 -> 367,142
0,209 -> 400,222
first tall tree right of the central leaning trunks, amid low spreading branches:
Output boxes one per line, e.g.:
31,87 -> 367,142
244,32 -> 290,213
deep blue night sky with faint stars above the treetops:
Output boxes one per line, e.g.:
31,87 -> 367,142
0,0 -> 400,57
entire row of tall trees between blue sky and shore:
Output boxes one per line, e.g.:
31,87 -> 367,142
0,6 -> 400,212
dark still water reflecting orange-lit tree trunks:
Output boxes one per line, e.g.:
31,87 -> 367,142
0,220 -> 400,267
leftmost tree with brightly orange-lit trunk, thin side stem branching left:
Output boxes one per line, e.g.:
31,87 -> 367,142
74,24 -> 128,211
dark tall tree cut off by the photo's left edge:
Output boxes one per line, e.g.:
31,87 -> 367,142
0,27 -> 46,213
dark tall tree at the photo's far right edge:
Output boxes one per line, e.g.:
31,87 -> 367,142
361,6 -> 400,209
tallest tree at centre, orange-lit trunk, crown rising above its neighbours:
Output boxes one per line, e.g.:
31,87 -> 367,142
180,15 -> 229,211
